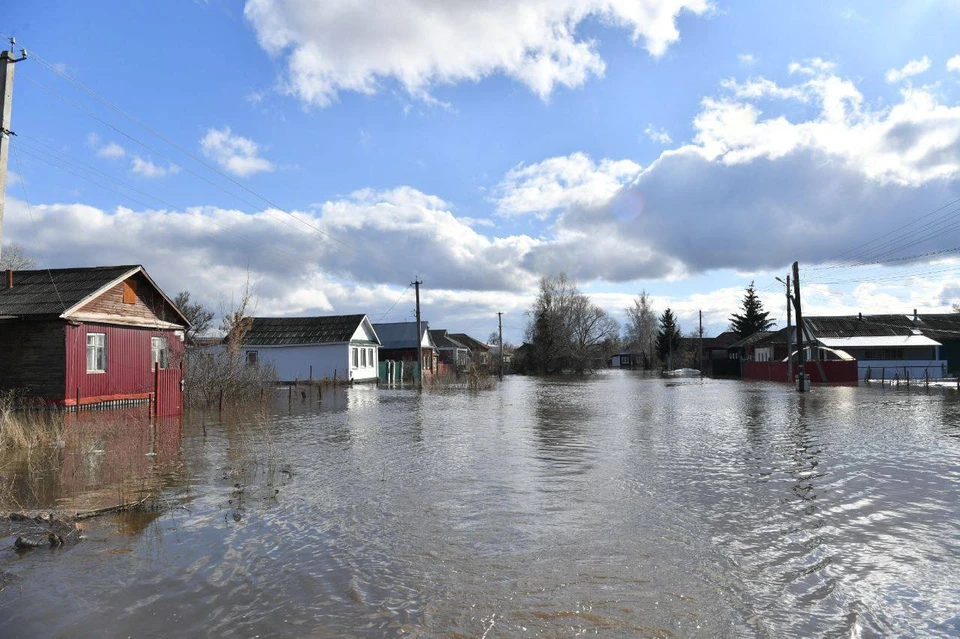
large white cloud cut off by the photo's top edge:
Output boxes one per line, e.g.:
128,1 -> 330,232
244,0 -> 710,106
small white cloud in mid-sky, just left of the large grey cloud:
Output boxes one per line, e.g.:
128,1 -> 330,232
496,153 -> 640,218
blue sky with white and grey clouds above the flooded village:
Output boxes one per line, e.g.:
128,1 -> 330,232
0,0 -> 960,341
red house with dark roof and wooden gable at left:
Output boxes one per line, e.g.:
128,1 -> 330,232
0,265 -> 190,415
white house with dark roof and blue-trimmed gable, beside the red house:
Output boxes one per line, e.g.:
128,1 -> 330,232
234,315 -> 380,382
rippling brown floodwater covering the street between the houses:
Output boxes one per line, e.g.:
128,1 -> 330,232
0,371 -> 960,637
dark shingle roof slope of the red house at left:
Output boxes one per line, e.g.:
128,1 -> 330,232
0,264 -> 140,317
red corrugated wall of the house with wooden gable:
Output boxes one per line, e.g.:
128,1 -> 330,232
64,324 -> 184,403
